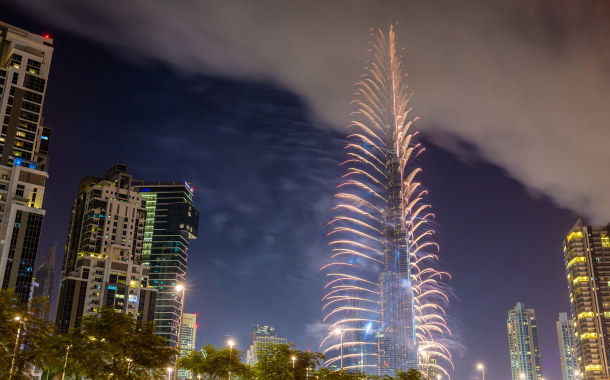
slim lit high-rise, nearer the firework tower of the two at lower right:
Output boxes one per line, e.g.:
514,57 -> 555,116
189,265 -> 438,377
507,302 -> 542,380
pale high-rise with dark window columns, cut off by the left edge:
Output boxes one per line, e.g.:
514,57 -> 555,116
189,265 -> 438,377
0,22 -> 53,302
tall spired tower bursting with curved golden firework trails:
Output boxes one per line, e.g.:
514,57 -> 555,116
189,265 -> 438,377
320,28 -> 453,378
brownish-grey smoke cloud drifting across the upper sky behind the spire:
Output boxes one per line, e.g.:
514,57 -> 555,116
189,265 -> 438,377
9,0 -> 610,222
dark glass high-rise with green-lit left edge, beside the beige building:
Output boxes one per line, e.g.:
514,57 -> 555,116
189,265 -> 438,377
134,181 -> 199,347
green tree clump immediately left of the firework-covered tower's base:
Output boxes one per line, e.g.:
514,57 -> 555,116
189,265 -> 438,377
252,343 -> 324,380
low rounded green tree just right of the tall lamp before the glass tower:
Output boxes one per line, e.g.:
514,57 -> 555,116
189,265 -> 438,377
178,344 -> 253,380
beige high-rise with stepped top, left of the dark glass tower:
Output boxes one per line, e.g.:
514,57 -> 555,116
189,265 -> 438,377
54,164 -> 157,333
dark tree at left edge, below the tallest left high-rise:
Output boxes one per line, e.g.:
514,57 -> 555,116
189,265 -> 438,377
0,289 -> 55,380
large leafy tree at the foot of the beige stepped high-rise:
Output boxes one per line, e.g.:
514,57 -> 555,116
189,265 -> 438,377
54,307 -> 179,380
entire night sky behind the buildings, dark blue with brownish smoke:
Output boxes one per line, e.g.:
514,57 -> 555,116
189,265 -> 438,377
0,1 -> 610,380
